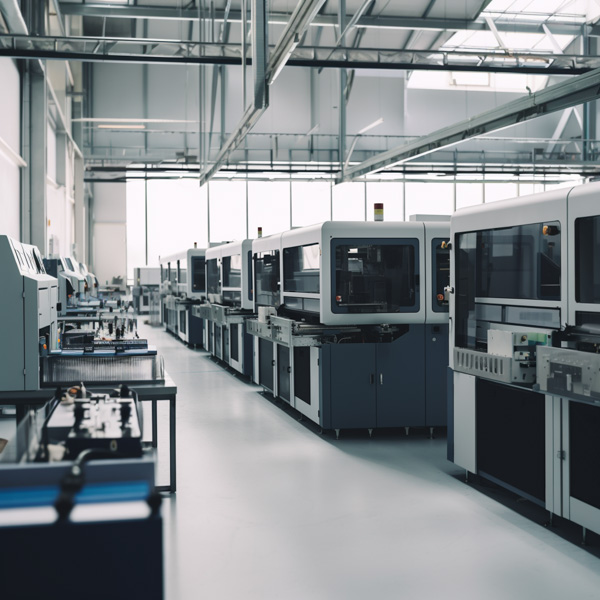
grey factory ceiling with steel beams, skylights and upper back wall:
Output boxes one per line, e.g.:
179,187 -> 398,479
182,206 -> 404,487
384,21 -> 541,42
0,0 -> 600,181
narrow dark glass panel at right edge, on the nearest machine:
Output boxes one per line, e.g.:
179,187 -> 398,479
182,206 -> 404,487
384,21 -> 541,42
575,216 -> 600,304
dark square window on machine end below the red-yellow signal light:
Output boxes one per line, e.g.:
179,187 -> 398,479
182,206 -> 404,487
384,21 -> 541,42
331,239 -> 419,314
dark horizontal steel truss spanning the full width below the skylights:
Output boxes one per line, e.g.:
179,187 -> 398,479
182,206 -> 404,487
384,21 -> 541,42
0,34 -> 600,74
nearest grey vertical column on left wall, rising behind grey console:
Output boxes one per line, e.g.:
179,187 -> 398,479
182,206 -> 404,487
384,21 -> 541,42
21,61 -> 48,254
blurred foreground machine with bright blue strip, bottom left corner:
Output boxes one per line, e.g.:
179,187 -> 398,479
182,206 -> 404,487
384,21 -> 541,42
0,386 -> 163,600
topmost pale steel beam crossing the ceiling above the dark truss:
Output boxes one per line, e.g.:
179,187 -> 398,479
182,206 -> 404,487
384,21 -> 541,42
60,2 -> 600,35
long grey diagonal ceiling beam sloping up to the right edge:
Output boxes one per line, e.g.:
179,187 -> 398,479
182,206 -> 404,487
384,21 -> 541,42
336,69 -> 600,183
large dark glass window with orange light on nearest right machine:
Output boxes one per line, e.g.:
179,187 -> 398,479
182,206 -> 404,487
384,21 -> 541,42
456,221 -> 561,351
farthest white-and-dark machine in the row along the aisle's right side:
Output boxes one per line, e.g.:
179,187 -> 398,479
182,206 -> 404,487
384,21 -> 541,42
160,247 -> 206,346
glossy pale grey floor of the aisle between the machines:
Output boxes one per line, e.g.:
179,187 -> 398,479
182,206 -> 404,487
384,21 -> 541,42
142,327 -> 600,600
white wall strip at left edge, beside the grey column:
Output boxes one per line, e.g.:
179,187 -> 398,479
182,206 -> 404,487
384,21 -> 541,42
0,58 -> 21,240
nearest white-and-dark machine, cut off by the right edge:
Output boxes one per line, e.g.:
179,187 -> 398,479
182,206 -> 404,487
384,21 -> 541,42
448,183 -> 600,533
